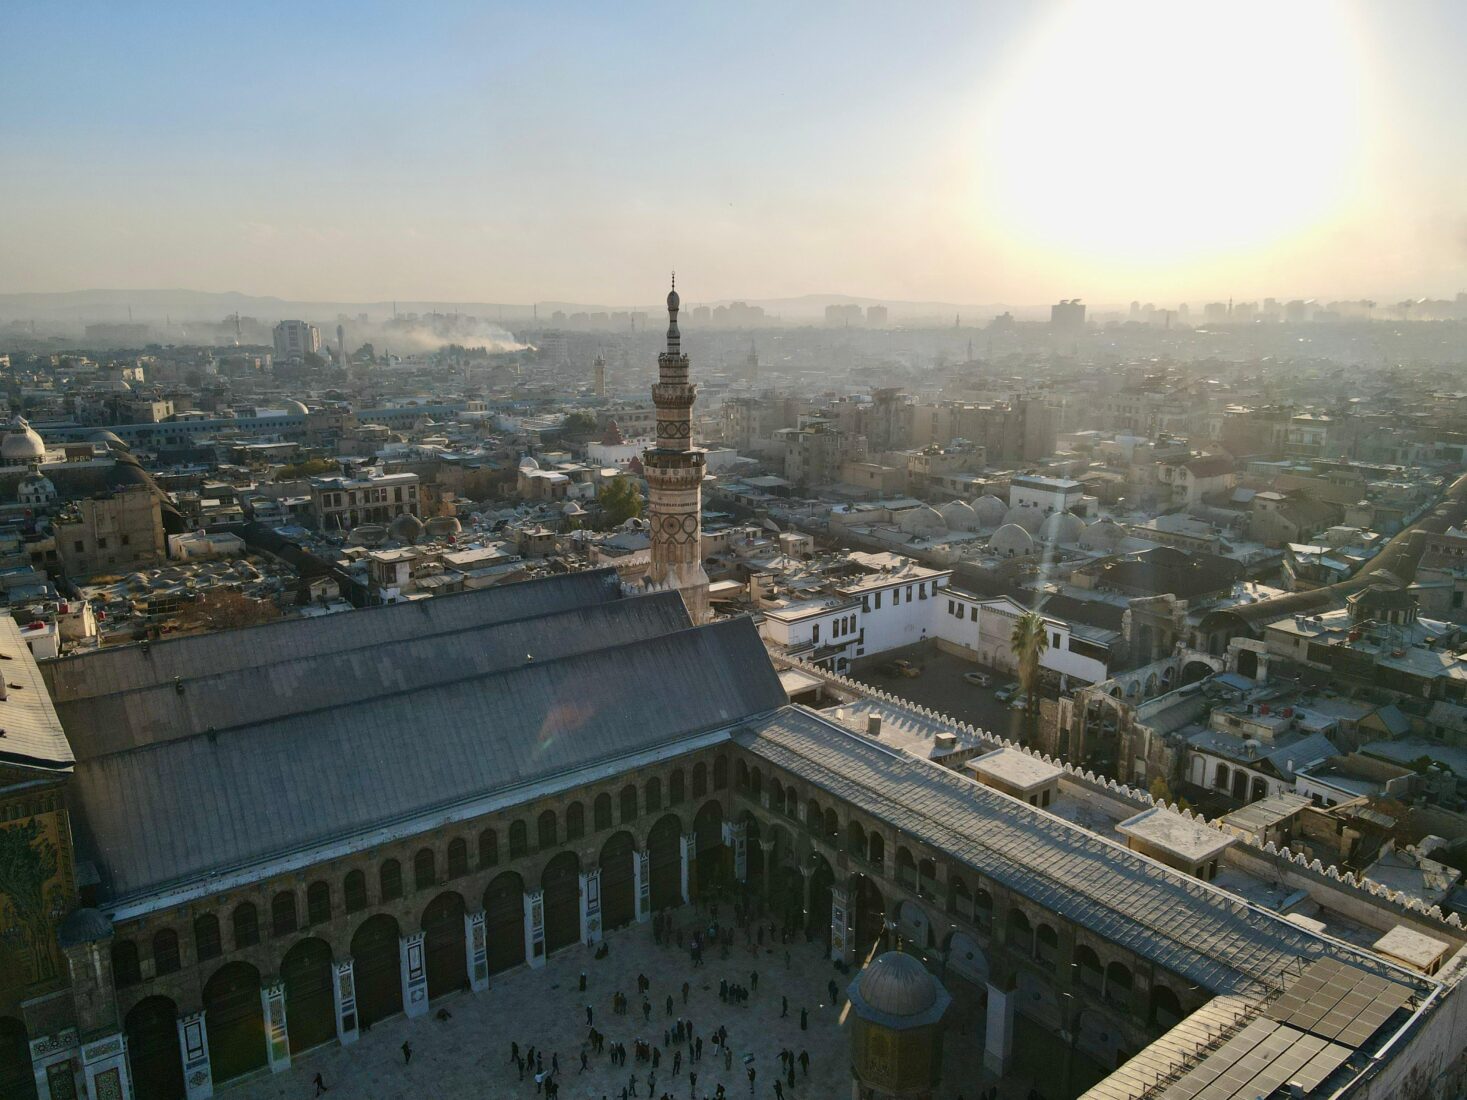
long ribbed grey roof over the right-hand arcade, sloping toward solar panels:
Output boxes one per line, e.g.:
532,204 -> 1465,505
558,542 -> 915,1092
735,707 -> 1414,993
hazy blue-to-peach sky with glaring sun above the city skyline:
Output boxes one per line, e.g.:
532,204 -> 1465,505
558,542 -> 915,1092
0,0 -> 1467,305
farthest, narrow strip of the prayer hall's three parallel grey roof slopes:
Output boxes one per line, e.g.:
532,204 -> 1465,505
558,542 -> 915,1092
44,569 -> 621,703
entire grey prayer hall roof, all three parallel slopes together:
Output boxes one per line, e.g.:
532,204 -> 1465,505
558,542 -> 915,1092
59,573 -> 785,920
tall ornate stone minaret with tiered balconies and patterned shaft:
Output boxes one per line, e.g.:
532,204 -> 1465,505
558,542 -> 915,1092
643,276 -> 709,622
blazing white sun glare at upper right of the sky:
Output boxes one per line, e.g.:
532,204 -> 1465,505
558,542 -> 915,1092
976,0 -> 1363,267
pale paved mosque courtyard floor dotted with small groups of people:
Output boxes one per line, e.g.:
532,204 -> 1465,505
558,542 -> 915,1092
214,908 -> 1093,1100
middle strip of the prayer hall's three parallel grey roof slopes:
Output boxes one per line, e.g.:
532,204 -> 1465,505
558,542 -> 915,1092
57,593 -> 691,760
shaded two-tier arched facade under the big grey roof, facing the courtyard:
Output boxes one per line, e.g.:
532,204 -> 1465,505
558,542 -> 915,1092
71,754 -> 739,1100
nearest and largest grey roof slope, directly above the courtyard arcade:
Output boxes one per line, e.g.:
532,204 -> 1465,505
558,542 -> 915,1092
73,616 -> 785,902
